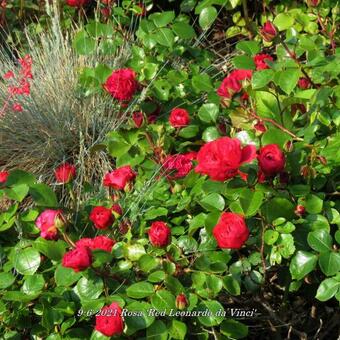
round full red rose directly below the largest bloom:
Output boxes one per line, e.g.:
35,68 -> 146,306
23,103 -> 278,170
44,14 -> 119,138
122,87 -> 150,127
213,212 -> 249,249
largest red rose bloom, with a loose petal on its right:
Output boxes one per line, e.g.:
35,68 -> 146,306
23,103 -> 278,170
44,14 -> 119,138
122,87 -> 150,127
195,137 -> 256,182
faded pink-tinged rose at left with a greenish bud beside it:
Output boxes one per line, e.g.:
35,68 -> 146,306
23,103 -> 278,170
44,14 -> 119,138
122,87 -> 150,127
35,209 -> 64,240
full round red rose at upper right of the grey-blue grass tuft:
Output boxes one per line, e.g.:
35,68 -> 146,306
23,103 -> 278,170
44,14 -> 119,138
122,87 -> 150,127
104,68 -> 138,101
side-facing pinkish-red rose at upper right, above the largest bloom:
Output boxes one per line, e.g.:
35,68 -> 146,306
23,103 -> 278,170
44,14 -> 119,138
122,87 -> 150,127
217,70 -> 253,98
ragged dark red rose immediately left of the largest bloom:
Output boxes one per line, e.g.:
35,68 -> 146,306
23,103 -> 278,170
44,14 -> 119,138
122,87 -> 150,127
163,152 -> 197,179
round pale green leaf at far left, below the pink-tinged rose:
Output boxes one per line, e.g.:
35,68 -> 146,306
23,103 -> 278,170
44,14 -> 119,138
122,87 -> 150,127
13,247 -> 41,275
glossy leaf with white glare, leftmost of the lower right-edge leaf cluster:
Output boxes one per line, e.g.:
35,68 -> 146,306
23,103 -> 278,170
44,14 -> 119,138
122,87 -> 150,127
289,250 -> 318,280
